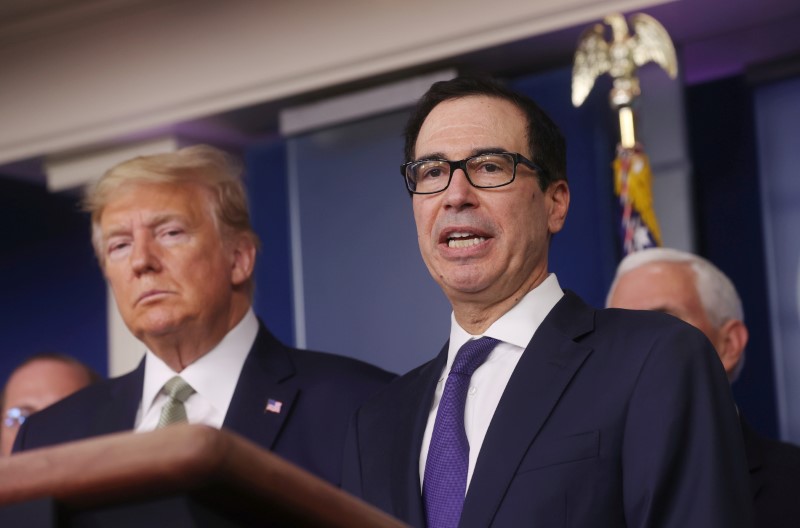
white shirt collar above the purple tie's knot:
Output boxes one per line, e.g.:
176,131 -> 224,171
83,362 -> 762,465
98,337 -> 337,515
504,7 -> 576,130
447,273 -> 564,360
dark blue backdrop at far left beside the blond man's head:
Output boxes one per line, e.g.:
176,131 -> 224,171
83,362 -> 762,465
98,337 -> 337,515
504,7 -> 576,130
0,179 -> 108,383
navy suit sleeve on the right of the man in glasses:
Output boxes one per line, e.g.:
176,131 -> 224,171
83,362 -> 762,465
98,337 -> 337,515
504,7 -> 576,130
622,326 -> 753,528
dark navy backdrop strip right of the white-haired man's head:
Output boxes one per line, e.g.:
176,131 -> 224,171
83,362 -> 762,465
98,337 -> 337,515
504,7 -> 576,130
686,77 -> 778,437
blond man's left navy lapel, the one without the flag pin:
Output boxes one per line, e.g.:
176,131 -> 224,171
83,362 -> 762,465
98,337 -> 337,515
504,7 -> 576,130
88,358 -> 144,436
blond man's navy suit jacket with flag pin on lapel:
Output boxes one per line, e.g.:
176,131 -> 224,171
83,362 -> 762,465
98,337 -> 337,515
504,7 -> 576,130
14,325 -> 394,484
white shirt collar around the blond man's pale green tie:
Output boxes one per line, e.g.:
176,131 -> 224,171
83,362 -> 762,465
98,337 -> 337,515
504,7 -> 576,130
142,308 -> 258,414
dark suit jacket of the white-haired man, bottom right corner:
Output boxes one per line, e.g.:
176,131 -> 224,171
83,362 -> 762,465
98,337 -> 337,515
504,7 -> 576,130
740,416 -> 800,528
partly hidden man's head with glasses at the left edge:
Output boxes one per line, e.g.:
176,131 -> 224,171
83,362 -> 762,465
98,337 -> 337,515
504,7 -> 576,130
0,352 -> 101,456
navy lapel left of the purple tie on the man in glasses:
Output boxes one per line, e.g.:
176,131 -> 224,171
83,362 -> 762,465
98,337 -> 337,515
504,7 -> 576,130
391,343 -> 448,526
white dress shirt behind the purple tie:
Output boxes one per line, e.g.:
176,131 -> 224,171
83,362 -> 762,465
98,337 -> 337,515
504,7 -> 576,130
419,273 -> 564,487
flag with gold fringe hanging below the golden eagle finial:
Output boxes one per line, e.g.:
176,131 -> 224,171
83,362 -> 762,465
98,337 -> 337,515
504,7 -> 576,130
613,143 -> 661,255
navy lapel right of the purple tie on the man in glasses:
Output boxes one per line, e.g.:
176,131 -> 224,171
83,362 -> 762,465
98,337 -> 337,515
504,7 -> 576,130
460,292 -> 594,527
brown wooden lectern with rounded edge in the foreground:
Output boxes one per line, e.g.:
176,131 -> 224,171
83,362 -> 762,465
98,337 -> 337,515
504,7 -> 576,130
0,425 -> 405,528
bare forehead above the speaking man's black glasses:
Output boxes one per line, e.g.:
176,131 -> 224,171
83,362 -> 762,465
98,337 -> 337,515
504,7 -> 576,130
414,96 -> 529,158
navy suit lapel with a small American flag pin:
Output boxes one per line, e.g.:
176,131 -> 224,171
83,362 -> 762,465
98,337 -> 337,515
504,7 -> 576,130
222,322 -> 297,449
